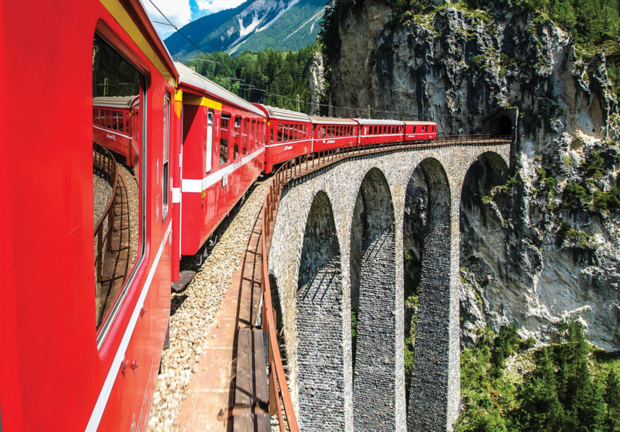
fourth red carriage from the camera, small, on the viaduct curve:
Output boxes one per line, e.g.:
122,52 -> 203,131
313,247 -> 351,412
311,117 -> 359,152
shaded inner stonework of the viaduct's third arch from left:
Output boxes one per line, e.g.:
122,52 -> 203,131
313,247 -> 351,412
403,158 -> 459,431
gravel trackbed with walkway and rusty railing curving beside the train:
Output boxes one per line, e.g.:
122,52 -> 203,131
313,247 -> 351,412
149,136 -> 510,432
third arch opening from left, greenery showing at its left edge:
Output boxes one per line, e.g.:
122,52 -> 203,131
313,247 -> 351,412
403,158 -> 453,430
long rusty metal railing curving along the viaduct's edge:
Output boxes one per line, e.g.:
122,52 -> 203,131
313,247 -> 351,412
261,135 -> 512,432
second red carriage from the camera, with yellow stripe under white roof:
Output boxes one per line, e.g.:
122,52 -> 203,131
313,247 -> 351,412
176,63 -> 267,262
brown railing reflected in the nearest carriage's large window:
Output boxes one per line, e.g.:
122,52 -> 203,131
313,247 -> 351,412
93,143 -> 118,283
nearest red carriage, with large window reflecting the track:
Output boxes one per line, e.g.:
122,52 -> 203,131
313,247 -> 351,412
0,0 -> 180,432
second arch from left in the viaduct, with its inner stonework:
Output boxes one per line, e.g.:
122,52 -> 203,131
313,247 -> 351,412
349,168 -> 396,431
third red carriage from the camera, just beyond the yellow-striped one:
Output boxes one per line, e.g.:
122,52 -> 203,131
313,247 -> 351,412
255,104 -> 312,174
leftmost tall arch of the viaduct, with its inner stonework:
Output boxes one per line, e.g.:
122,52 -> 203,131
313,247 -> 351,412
296,191 -> 344,431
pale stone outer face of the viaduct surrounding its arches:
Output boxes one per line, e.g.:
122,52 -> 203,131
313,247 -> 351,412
269,145 -> 510,431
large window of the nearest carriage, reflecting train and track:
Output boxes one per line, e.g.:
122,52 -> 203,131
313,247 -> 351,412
92,34 -> 146,348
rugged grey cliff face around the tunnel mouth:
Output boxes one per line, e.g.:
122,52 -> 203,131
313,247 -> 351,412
329,0 -> 620,349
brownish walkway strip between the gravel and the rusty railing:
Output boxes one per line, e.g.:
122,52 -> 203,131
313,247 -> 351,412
178,211 -> 270,431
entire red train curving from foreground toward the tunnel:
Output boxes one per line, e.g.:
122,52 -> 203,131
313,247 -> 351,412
0,0 -> 437,432
